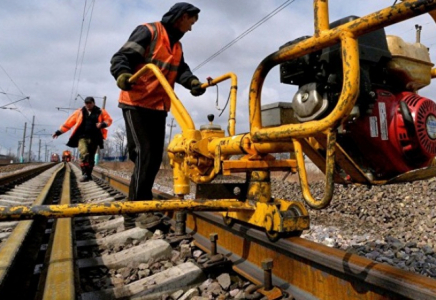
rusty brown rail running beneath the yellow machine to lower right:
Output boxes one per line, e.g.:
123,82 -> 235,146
94,170 -> 436,300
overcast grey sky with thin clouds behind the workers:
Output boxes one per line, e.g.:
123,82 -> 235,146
0,0 -> 436,158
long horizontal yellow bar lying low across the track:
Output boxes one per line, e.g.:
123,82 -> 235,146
0,199 -> 253,221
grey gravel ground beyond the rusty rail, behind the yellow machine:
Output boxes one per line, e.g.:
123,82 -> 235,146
99,162 -> 436,278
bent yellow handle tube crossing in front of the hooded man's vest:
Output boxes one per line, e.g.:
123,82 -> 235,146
129,64 -> 195,132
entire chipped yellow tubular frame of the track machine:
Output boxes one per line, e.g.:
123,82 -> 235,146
0,0 -> 436,237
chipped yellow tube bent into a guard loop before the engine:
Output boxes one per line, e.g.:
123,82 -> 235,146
249,0 -> 436,141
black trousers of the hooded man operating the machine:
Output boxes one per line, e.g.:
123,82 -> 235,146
123,108 -> 167,200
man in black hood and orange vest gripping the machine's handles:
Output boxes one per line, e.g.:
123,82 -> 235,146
110,2 -> 205,228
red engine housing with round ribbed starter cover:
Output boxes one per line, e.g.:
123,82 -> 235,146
344,90 -> 436,179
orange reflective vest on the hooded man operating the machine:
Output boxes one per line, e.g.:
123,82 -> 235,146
118,22 -> 182,111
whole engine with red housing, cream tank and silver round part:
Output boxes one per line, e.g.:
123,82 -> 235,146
280,16 -> 436,180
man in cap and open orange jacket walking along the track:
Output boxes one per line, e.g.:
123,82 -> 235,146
53,97 -> 112,182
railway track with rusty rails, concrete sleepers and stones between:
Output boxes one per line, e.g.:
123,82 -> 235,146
0,164 -> 436,299
